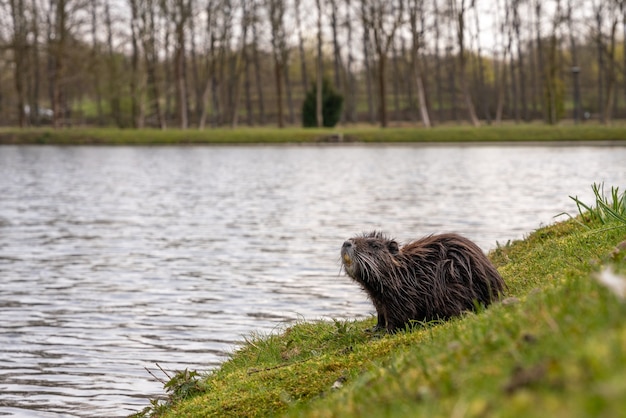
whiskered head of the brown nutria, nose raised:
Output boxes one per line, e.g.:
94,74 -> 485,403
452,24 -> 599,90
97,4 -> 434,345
341,231 -> 400,285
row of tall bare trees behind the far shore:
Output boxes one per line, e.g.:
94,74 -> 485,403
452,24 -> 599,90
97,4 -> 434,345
0,0 -> 626,129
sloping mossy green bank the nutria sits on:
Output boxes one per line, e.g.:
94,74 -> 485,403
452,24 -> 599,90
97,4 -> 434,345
133,188 -> 626,418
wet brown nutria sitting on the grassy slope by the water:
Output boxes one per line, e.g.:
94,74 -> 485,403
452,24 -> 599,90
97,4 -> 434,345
341,232 -> 505,332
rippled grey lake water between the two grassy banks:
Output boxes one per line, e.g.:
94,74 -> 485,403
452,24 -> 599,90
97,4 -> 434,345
0,145 -> 626,417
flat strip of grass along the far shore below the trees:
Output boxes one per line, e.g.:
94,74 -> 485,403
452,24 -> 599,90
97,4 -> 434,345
0,124 -> 626,145
